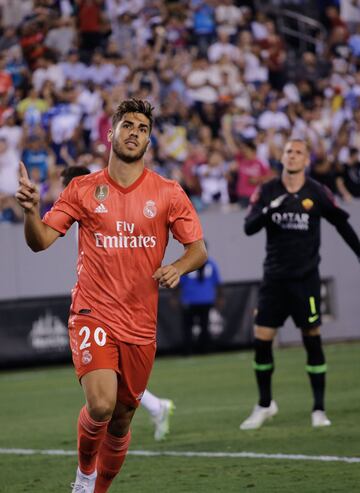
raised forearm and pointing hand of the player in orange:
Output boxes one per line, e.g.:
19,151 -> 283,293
15,162 -> 60,252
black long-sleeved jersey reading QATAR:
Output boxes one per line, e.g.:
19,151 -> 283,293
245,178 -> 360,279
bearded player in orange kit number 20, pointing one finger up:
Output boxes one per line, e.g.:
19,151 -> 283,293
16,99 -> 207,493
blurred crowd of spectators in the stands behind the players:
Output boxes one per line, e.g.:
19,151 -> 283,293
0,0 -> 360,221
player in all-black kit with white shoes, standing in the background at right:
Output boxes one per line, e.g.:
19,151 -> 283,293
240,139 -> 360,430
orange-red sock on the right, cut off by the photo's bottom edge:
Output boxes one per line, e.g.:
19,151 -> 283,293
95,431 -> 131,493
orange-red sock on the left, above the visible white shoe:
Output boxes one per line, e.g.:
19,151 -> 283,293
78,406 -> 110,475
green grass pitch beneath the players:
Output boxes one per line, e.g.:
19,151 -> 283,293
0,343 -> 360,493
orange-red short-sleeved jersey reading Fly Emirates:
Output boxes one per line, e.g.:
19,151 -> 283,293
43,169 -> 203,344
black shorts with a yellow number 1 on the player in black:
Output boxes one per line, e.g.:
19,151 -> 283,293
255,271 -> 321,329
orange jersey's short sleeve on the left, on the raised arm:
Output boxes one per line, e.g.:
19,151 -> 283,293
43,178 -> 82,235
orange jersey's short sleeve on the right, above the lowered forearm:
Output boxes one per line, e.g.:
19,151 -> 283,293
168,183 -> 203,245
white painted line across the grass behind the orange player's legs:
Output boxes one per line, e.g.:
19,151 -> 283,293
0,448 -> 360,464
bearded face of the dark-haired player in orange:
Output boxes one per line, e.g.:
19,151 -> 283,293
109,113 -> 150,163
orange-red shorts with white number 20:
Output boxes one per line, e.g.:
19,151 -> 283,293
69,316 -> 156,407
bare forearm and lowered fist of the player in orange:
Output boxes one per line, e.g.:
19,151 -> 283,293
153,240 -> 207,288
